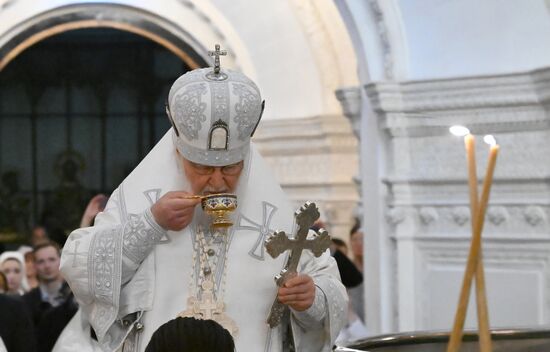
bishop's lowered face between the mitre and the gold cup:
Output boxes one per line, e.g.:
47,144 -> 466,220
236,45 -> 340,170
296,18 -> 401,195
180,156 -> 244,195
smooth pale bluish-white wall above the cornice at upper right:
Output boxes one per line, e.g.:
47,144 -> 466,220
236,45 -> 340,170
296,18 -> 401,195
399,0 -> 550,80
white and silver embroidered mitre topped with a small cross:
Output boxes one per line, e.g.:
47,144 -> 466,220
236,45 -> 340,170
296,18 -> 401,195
166,45 -> 264,166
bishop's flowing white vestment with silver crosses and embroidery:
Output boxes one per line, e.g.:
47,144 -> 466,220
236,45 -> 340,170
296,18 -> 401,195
54,131 -> 347,352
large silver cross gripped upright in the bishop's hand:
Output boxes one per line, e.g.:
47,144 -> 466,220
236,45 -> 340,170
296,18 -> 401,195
265,202 -> 330,328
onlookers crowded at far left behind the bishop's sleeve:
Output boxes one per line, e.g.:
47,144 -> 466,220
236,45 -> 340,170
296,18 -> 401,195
0,194 -> 107,352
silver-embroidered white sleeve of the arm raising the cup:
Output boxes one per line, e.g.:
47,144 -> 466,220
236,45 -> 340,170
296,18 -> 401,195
61,189 -> 165,345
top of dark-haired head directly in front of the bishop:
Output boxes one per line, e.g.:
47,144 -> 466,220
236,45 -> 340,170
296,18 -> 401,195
145,317 -> 235,352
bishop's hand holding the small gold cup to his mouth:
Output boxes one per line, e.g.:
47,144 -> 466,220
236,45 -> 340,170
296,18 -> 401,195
151,191 -> 201,231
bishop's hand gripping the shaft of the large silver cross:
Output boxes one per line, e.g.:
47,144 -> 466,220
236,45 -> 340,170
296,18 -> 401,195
277,274 -> 315,312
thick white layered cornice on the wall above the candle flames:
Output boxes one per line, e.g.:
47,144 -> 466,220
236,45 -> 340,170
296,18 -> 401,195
364,68 -> 550,137
